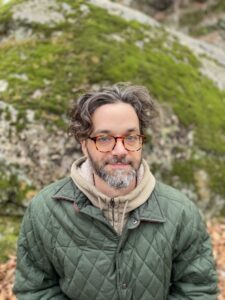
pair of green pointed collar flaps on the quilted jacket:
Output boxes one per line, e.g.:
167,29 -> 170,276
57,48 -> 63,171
52,178 -> 166,224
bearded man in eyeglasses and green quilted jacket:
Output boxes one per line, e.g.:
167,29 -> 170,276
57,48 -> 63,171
14,84 -> 217,300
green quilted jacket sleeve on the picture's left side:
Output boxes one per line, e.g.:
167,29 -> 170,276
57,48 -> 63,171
13,205 -> 69,300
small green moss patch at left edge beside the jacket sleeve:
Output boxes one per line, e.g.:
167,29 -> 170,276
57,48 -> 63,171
0,216 -> 21,263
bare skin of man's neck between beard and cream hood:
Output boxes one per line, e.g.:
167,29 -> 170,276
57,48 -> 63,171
93,174 -> 137,198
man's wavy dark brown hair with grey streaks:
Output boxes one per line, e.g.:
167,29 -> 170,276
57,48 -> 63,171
69,83 -> 158,142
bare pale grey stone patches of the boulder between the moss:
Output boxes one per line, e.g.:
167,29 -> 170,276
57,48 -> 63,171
0,0 -> 225,218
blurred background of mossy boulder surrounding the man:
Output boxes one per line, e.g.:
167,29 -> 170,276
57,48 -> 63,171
0,0 -> 225,299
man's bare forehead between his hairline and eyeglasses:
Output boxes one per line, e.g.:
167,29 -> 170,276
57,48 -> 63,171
92,102 -> 140,134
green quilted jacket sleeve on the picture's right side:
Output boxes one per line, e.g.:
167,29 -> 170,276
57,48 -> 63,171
167,205 -> 218,300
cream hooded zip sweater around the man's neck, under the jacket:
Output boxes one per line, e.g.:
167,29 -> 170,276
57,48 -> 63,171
71,157 -> 155,234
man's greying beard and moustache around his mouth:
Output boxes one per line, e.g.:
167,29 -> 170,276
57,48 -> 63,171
88,153 -> 141,189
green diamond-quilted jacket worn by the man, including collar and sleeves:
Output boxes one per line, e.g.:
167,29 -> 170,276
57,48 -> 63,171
14,178 -> 217,300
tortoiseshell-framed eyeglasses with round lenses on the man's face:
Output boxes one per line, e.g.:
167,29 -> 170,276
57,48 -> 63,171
88,134 -> 144,152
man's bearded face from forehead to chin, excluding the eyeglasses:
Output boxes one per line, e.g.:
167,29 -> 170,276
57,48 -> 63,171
81,102 -> 142,189
